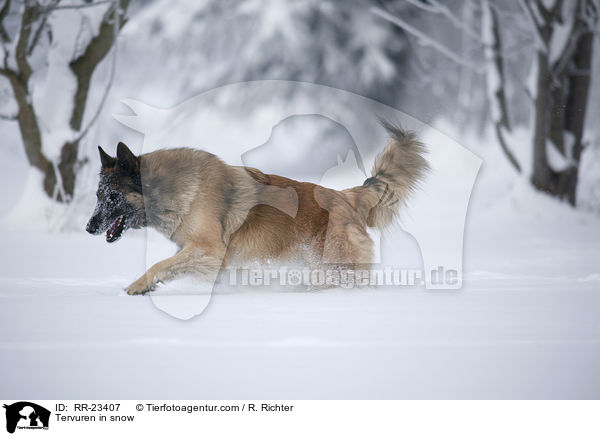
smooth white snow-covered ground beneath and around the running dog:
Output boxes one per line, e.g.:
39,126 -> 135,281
0,116 -> 600,399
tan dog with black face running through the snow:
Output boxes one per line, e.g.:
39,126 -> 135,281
86,124 -> 428,294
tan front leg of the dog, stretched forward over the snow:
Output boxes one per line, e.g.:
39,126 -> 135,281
126,246 -> 224,295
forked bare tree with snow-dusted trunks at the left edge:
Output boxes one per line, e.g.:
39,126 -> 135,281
0,0 -> 129,202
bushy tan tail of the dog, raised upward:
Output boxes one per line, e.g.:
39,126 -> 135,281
363,121 -> 429,229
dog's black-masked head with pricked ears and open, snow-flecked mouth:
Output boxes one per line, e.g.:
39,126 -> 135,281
86,142 -> 146,242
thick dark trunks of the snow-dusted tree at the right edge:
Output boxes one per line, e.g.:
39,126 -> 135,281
522,0 -> 600,205
